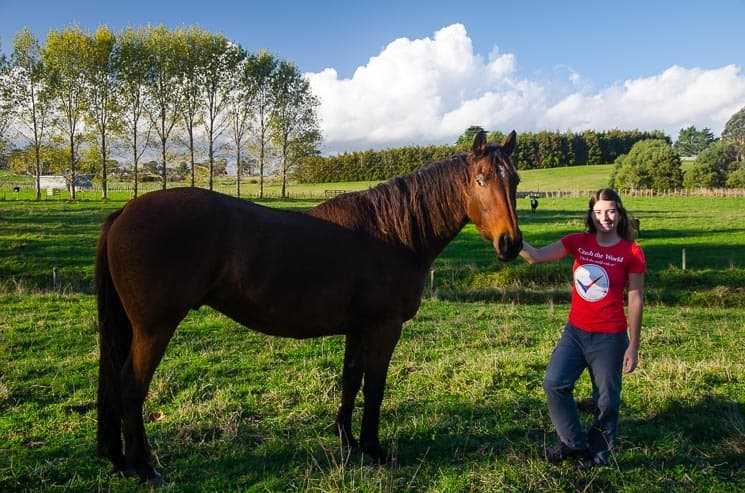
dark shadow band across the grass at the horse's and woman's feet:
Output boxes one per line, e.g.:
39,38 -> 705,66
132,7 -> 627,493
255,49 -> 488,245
0,386 -> 745,491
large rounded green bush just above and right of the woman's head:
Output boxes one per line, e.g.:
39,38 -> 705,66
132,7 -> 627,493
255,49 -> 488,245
610,139 -> 683,190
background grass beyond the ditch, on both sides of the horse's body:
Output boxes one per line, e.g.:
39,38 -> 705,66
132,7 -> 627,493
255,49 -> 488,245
0,197 -> 745,307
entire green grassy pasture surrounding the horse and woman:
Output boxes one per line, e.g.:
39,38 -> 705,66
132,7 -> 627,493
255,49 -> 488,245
0,185 -> 745,492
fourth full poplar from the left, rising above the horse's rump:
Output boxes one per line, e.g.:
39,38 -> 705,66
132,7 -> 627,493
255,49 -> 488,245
115,28 -> 153,197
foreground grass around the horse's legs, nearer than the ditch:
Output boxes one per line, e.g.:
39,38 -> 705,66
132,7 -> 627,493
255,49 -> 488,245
0,294 -> 745,492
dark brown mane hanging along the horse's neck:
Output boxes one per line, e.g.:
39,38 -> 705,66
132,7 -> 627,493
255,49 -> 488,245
308,154 -> 468,250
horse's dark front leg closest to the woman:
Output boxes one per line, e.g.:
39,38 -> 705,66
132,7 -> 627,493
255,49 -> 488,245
360,324 -> 401,464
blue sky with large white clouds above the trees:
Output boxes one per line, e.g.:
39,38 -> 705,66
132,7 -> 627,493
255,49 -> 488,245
0,0 -> 745,152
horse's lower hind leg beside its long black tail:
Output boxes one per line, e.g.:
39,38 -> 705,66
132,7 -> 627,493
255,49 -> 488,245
122,324 -> 176,481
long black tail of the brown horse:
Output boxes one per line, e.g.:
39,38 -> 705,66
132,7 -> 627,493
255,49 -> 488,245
96,211 -> 132,465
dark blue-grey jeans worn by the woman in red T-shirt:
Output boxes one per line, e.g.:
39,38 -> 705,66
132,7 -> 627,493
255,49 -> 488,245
543,323 -> 629,463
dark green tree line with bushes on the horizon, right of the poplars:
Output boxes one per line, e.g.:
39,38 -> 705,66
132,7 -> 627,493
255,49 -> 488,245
295,108 -> 745,190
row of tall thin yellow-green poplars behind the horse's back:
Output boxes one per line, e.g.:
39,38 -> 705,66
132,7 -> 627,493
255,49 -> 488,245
0,26 -> 321,199
